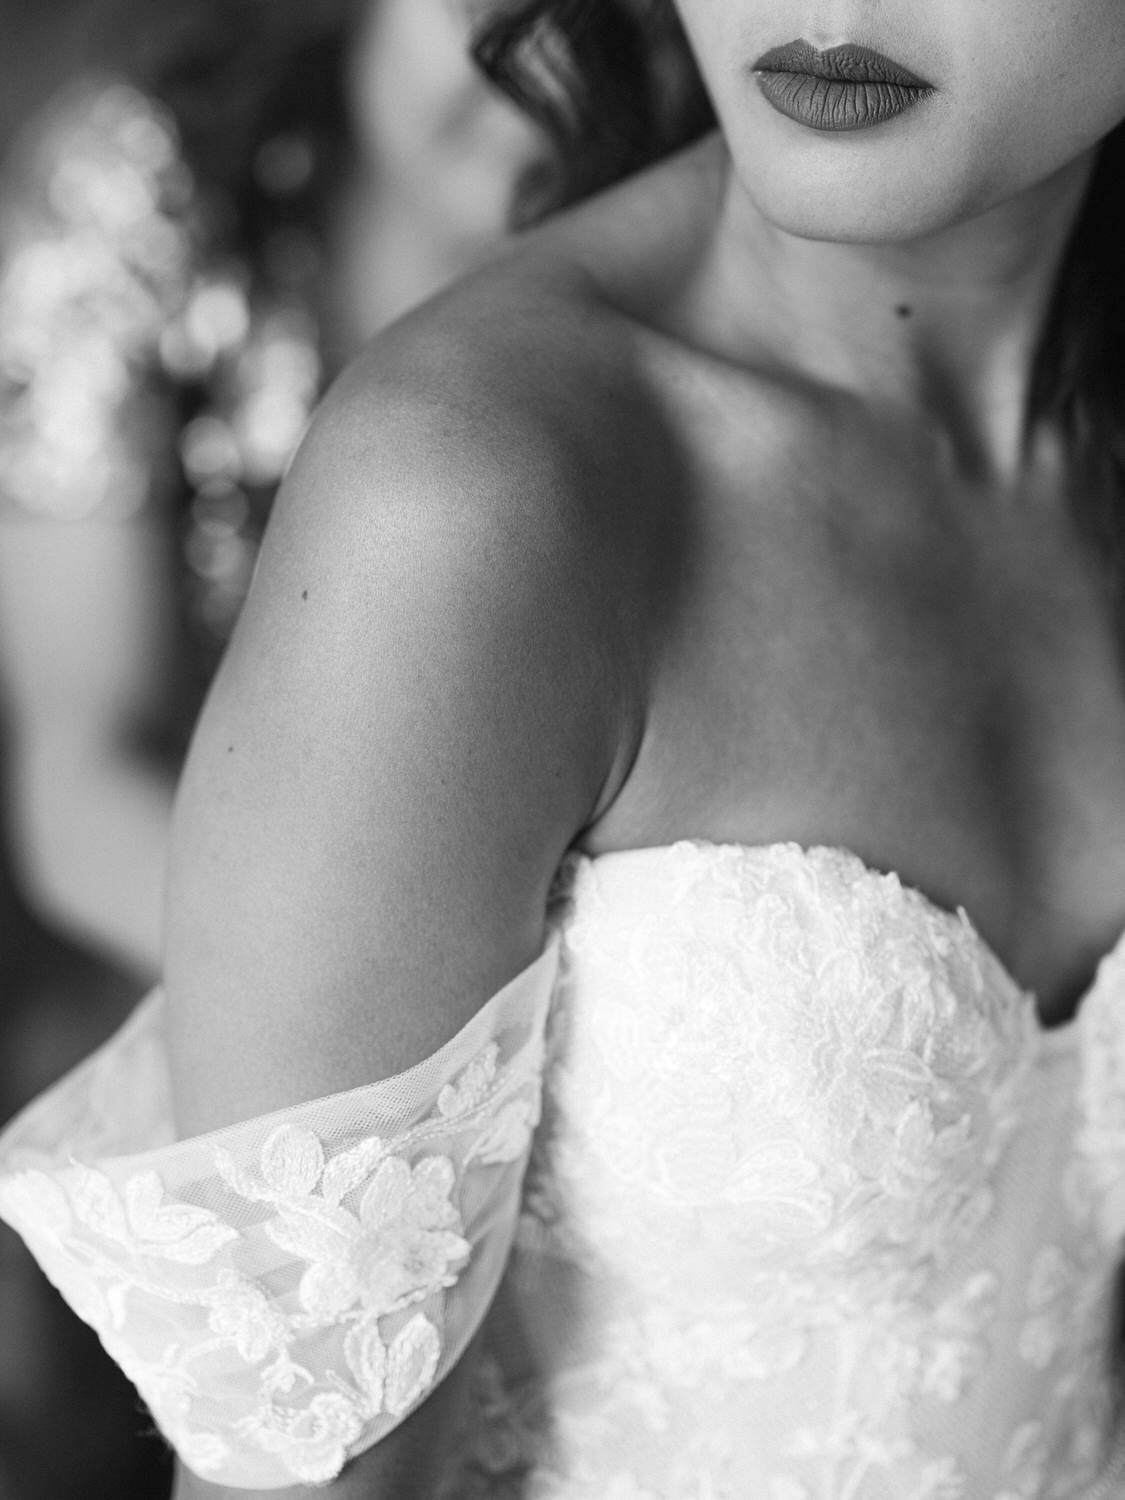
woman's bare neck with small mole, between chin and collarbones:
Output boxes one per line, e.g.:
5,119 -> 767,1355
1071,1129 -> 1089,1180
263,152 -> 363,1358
695,141 -> 1094,479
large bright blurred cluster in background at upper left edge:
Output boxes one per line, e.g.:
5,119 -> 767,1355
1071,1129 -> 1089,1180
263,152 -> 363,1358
0,81 -> 198,521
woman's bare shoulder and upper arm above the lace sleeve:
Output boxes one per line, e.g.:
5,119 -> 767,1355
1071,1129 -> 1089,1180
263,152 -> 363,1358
165,141 -> 744,1131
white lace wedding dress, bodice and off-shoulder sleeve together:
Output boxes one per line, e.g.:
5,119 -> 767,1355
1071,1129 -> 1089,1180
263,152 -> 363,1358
0,843 -> 1125,1500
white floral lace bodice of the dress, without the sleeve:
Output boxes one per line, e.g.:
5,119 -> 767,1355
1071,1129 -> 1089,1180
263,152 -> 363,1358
462,843 -> 1125,1500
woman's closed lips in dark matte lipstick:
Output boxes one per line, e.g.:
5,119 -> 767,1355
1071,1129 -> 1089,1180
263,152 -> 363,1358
753,41 -> 935,131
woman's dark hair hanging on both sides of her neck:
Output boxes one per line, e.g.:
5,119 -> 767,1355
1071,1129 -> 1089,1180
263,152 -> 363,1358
474,0 -> 1125,531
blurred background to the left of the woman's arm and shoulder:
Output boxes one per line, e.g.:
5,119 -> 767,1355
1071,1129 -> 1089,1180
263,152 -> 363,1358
0,0 -> 551,1500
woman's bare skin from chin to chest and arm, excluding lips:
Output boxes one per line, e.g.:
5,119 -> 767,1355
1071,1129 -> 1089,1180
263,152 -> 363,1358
167,0 -> 1125,1500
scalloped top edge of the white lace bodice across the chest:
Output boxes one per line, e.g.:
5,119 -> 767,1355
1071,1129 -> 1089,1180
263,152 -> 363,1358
572,839 -> 1125,1049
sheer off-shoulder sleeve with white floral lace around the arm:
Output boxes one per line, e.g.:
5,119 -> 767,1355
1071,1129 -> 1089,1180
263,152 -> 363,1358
0,939 -> 557,1490
